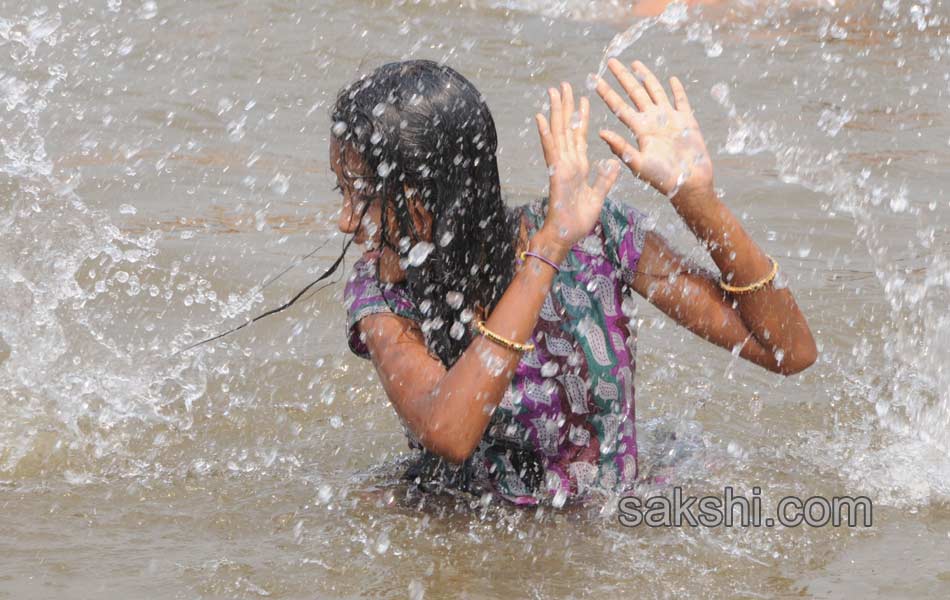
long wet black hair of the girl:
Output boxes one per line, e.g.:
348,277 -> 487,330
332,60 -> 517,366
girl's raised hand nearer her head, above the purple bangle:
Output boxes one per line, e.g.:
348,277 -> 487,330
535,83 -> 620,249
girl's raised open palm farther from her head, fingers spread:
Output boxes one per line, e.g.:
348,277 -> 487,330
597,59 -> 713,197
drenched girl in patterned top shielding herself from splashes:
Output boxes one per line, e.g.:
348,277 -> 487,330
330,60 -> 817,506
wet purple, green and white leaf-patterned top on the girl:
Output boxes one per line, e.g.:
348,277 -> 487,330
344,198 -> 646,506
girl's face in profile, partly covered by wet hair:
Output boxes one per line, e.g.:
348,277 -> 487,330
330,138 -> 431,283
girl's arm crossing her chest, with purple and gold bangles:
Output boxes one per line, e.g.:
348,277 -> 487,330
359,84 -> 620,462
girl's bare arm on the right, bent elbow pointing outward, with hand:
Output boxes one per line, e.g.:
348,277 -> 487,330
597,59 -> 818,375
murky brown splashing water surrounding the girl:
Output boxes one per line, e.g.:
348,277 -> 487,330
0,0 -> 950,598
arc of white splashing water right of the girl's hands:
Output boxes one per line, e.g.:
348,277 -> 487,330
588,2 -> 950,502
